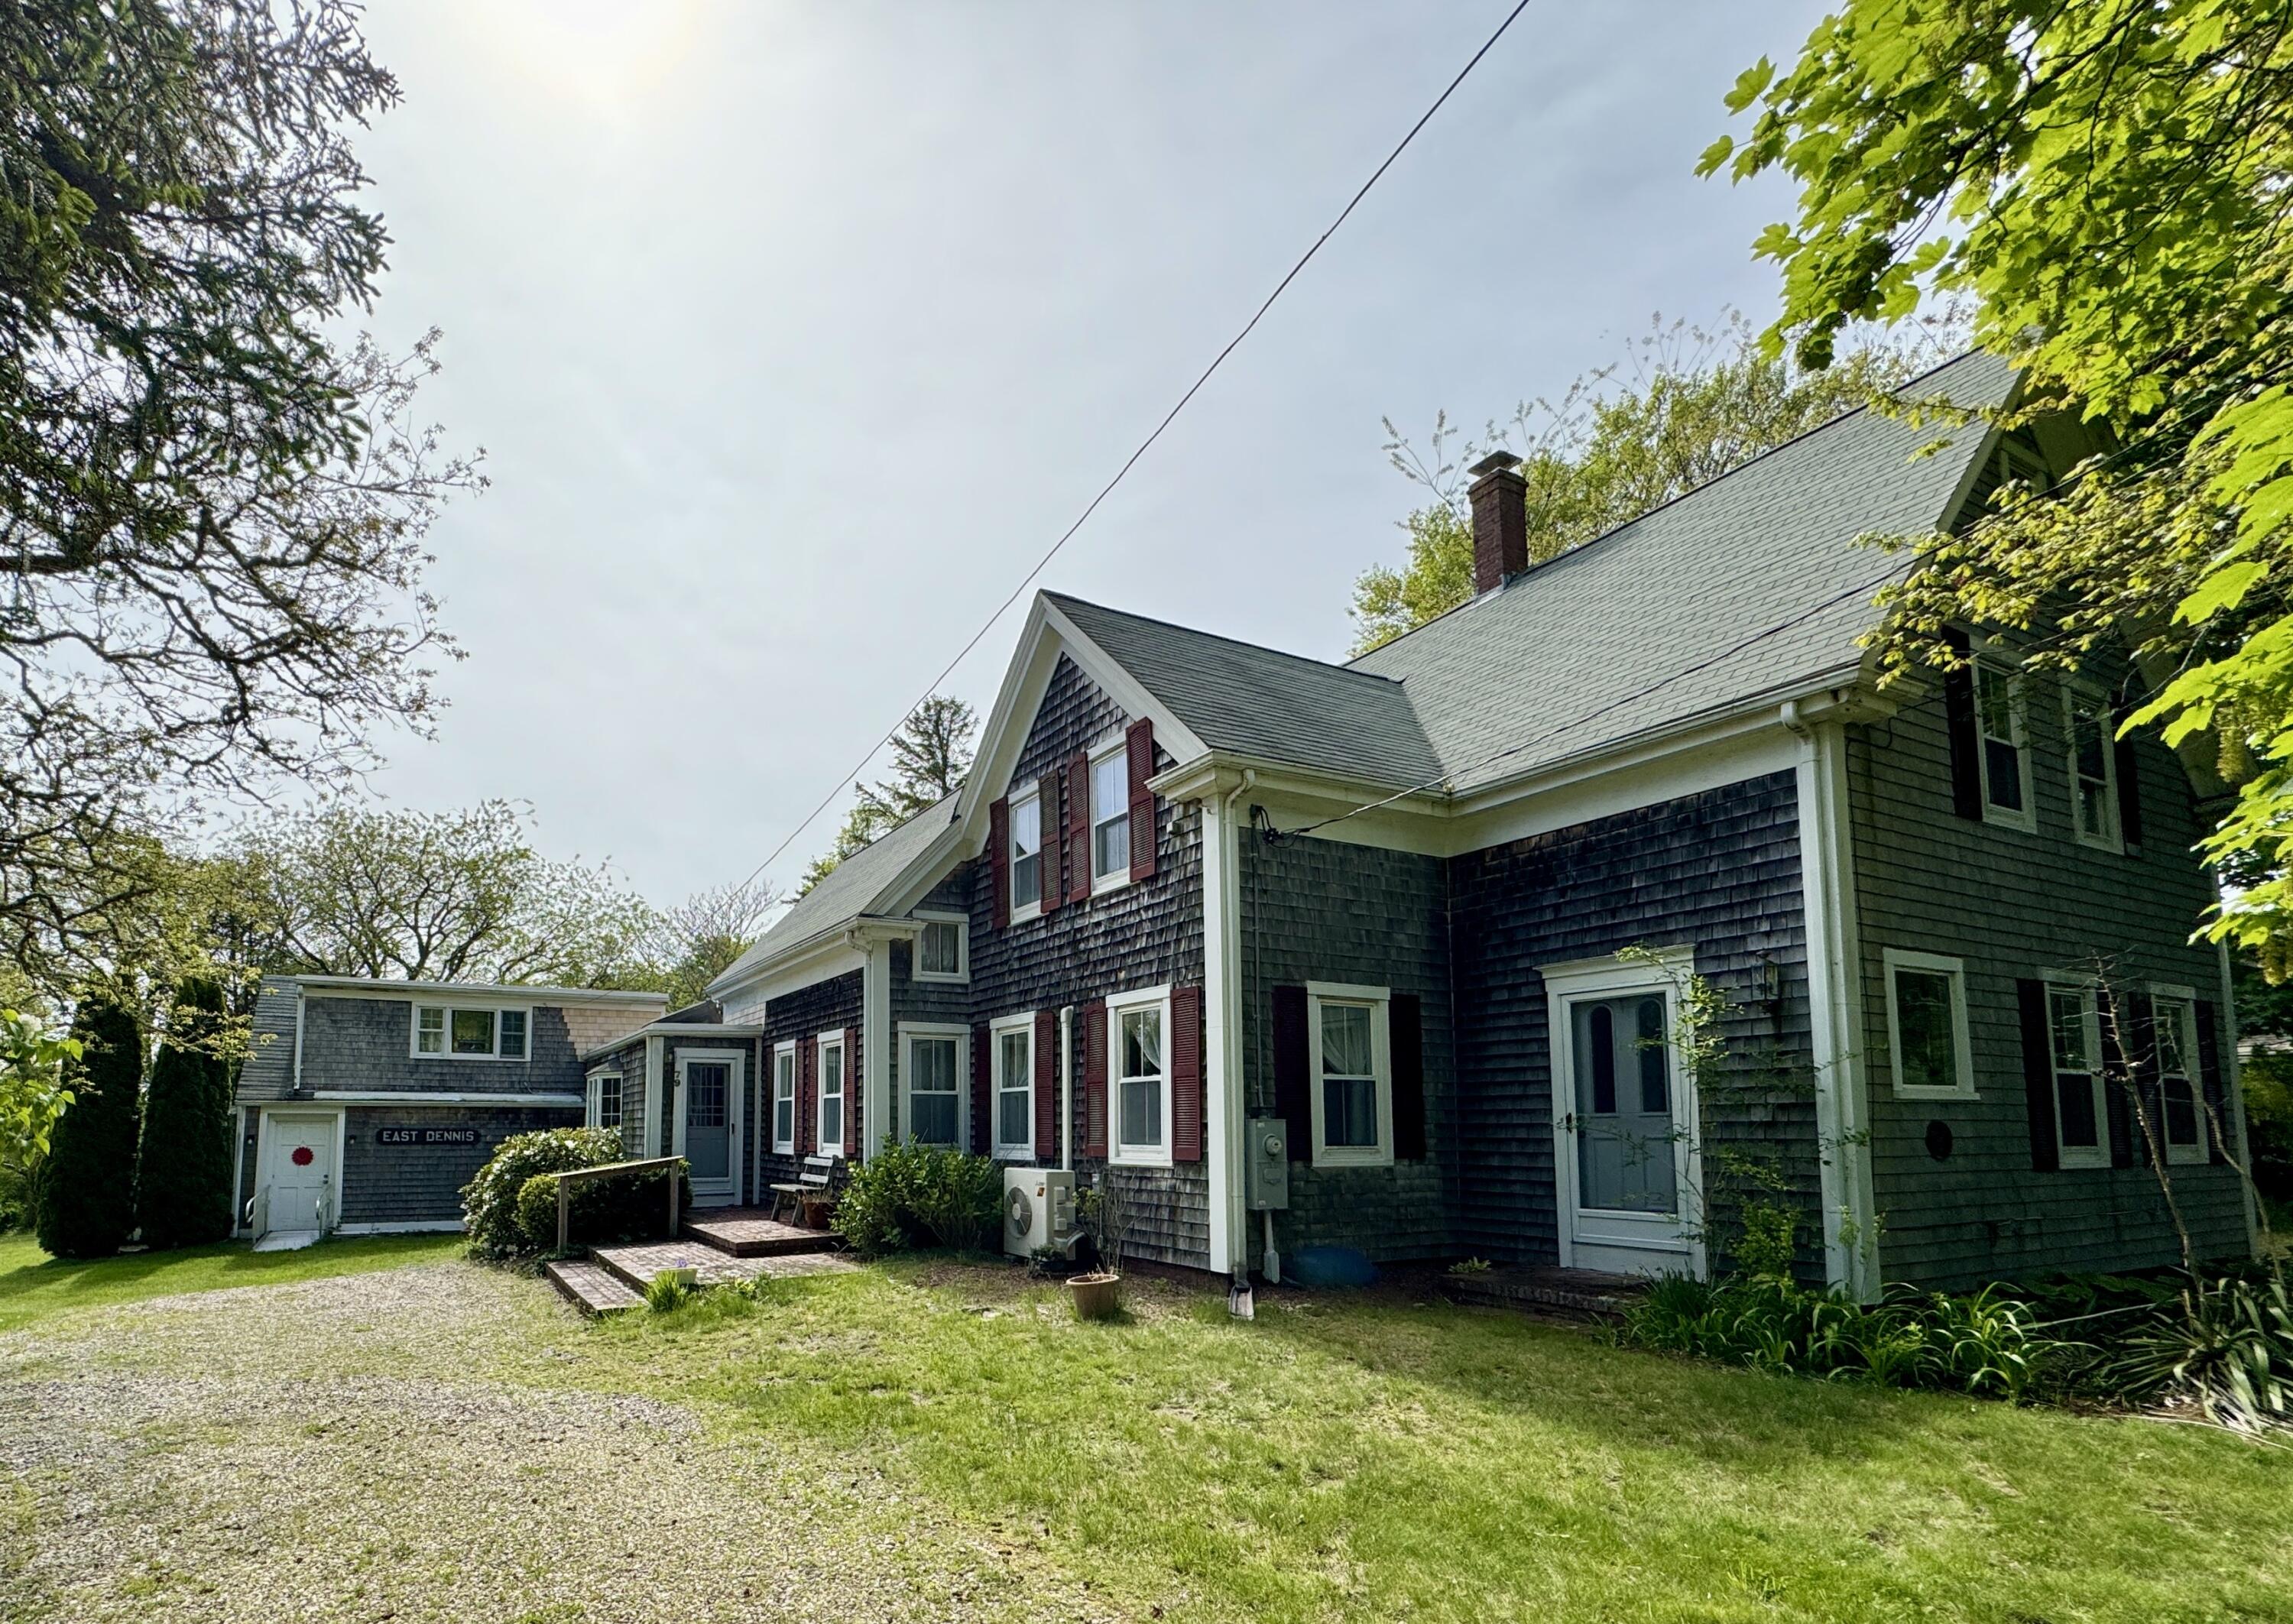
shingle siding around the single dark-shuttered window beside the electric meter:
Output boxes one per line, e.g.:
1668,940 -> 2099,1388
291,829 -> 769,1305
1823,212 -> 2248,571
1236,833 -> 1458,1269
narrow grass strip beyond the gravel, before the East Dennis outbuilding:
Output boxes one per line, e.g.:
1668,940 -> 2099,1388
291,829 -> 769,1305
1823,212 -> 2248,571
0,1234 -> 463,1331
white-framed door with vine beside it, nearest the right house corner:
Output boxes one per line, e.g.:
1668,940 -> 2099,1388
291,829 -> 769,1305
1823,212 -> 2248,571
1545,959 -> 1704,1276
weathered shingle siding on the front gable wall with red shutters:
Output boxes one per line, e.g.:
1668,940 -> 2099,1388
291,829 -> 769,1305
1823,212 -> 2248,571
965,656 -> 1211,1269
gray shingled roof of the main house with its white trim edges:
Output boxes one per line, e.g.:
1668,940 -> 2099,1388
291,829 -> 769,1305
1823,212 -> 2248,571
709,353 -> 2016,994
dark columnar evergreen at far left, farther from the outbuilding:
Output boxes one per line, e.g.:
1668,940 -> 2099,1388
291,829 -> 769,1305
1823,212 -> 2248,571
32,996 -> 142,1257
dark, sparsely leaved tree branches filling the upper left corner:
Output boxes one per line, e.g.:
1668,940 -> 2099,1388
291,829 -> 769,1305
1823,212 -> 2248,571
0,0 -> 477,987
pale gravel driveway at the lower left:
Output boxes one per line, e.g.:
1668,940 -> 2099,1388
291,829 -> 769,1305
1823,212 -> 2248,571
0,1264 -> 1091,1624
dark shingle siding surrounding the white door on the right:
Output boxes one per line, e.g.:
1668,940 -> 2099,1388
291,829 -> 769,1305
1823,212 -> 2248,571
1440,773 -> 1821,1280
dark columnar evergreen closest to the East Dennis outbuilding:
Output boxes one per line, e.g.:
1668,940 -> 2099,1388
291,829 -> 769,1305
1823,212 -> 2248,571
135,980 -> 232,1246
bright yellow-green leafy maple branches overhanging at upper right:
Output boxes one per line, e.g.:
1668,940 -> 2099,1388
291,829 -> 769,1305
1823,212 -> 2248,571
1704,0 -> 2293,973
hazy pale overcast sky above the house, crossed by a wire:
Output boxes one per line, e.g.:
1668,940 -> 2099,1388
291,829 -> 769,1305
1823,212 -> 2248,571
344,0 -> 1821,904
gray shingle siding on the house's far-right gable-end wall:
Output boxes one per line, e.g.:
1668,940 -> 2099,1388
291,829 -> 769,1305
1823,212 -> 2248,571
1848,674 -> 2249,1285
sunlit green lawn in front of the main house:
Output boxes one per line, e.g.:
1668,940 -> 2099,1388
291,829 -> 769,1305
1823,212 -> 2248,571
569,1259 -> 2293,1624
